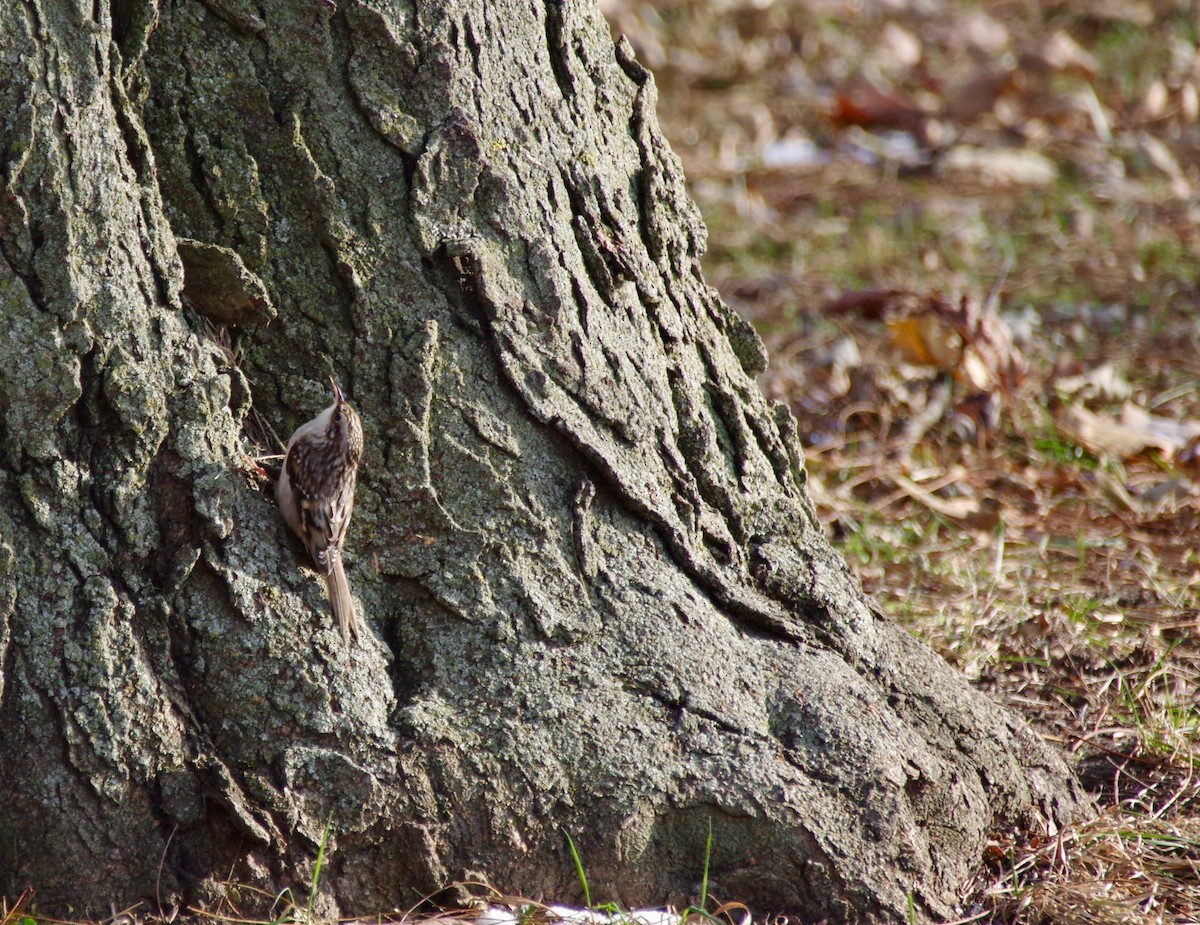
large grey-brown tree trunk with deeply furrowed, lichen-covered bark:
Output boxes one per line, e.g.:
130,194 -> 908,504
0,0 -> 1078,921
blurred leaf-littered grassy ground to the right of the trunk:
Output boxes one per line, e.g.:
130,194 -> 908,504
601,0 -> 1200,923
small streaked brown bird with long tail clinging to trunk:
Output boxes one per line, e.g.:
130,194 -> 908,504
275,378 -> 362,645
